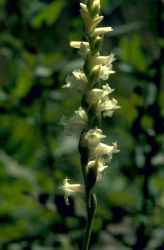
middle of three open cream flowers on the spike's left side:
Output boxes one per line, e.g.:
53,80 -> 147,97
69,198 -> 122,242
60,107 -> 88,135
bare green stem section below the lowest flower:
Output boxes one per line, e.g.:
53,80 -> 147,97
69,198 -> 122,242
82,190 -> 97,250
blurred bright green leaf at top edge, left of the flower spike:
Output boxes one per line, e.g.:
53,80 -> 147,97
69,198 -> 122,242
31,0 -> 65,28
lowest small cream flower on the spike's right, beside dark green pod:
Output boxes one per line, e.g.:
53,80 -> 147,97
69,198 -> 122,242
87,158 -> 108,181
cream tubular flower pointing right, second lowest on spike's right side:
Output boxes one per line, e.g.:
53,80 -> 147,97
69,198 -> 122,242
90,142 -> 119,161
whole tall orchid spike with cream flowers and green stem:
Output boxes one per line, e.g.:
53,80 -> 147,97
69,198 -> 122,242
61,0 -> 120,250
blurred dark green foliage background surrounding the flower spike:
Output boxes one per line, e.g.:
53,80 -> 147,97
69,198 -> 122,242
0,0 -> 164,250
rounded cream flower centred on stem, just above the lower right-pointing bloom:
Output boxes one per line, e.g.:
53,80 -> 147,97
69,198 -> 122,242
82,128 -> 106,149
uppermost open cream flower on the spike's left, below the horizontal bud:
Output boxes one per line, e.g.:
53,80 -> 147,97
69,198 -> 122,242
63,70 -> 87,91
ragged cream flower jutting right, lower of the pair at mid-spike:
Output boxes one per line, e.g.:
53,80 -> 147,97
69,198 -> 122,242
97,97 -> 120,117
